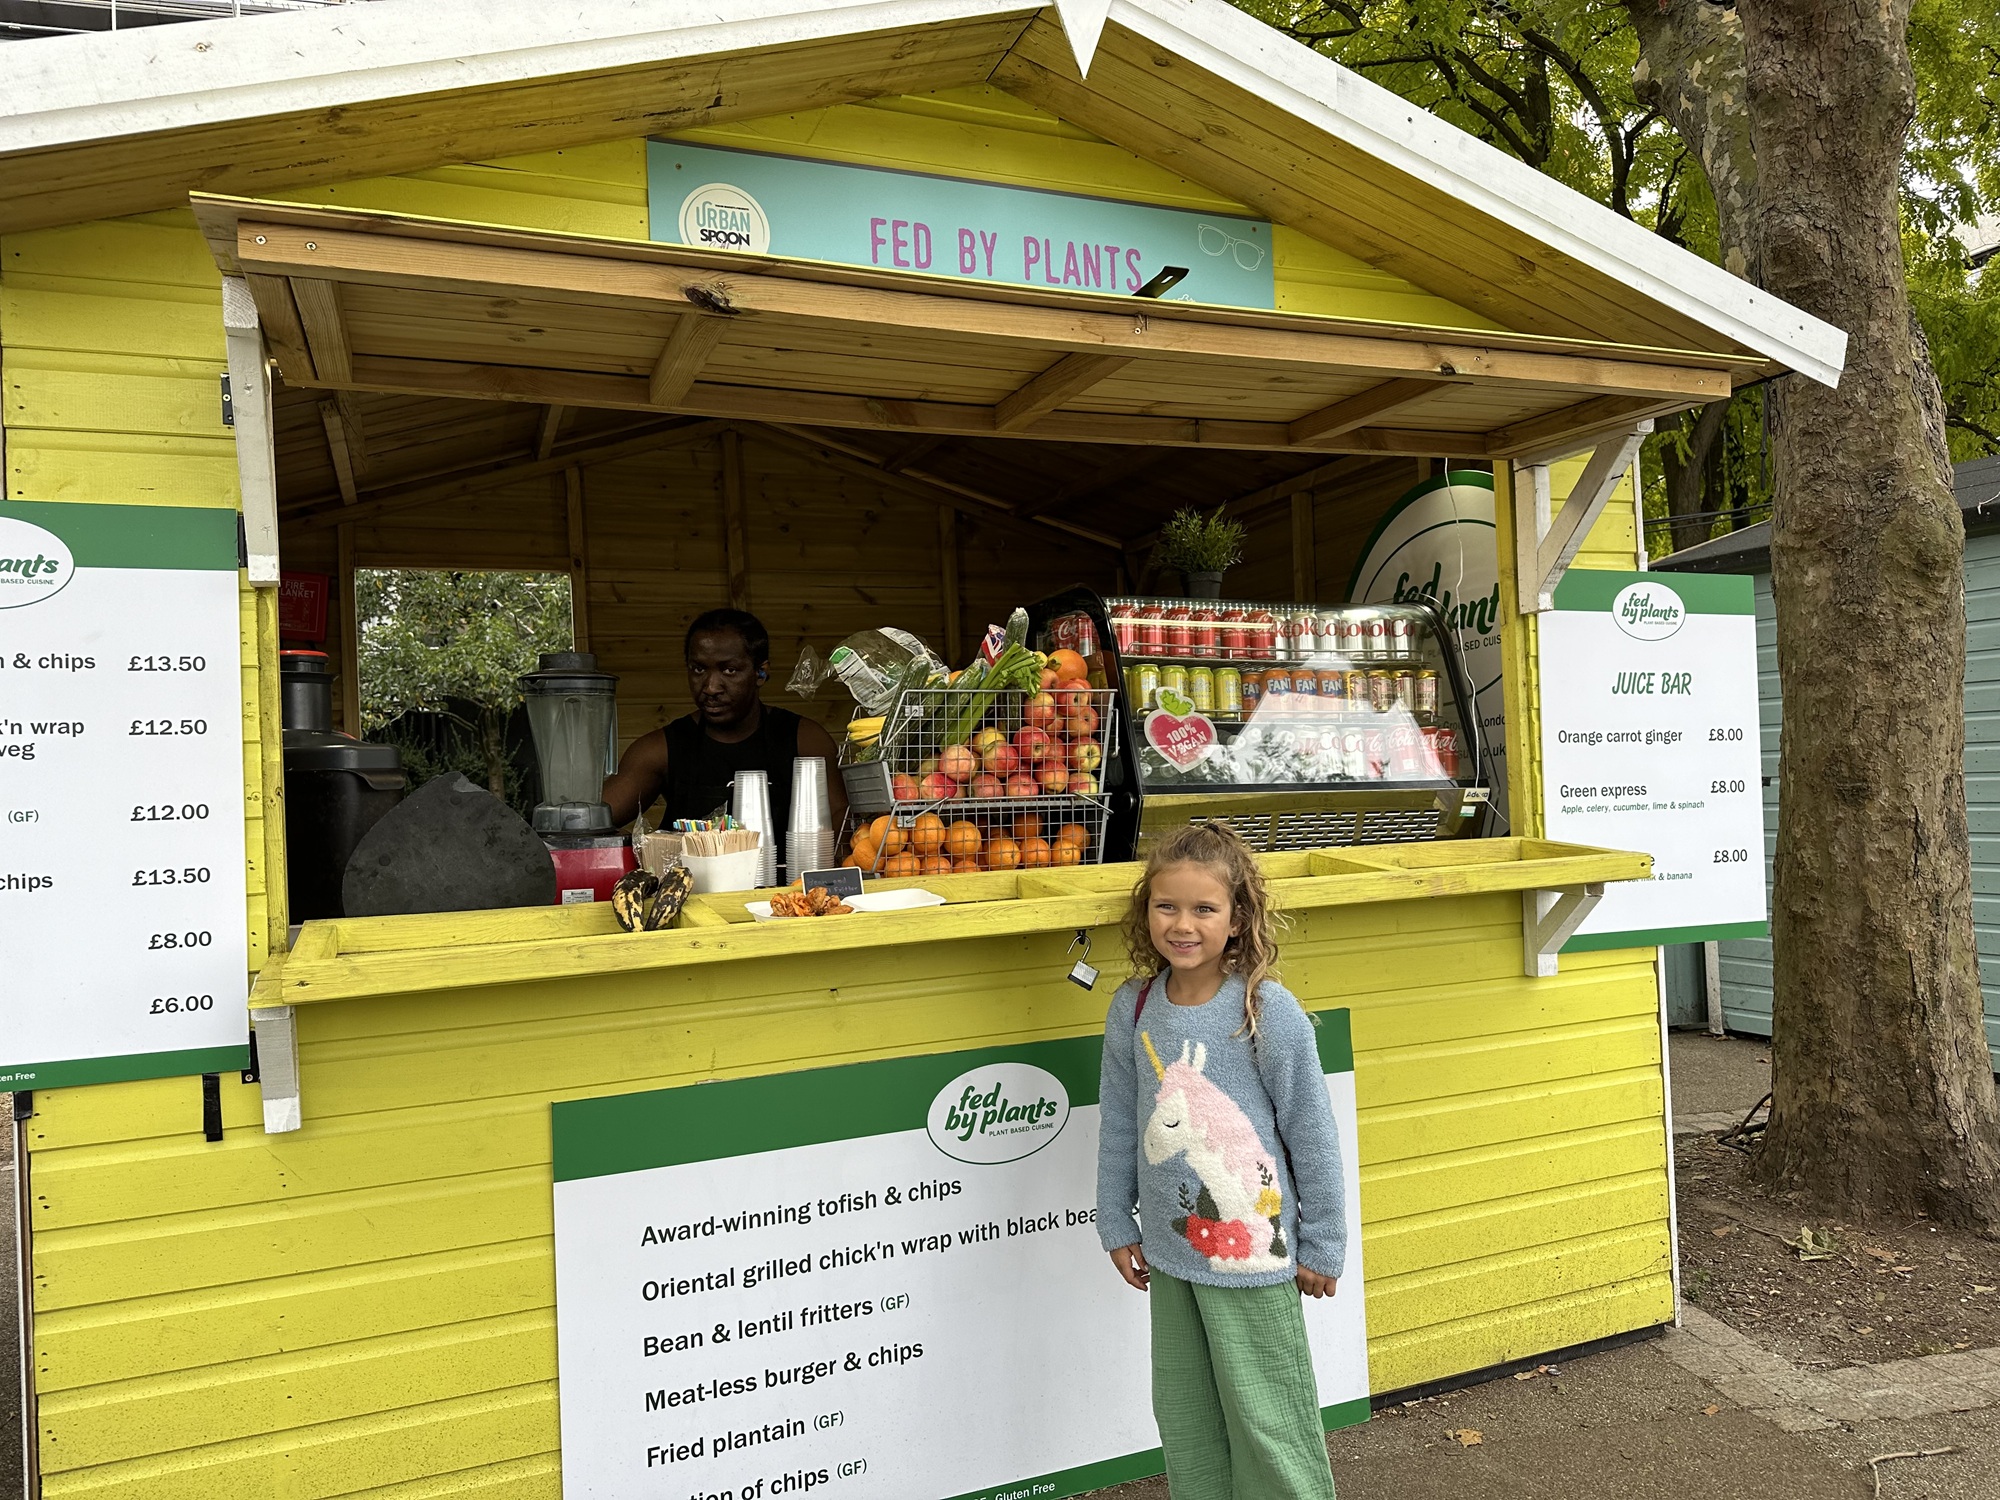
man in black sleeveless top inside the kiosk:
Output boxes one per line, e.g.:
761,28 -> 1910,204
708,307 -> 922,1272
604,610 -> 848,848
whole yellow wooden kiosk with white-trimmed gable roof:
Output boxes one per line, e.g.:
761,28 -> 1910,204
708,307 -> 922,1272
0,0 -> 1842,1500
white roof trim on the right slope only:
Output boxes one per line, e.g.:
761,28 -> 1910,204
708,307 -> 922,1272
1112,0 -> 1848,386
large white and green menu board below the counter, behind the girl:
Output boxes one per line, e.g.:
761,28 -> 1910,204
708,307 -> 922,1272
554,1032 -> 1368,1500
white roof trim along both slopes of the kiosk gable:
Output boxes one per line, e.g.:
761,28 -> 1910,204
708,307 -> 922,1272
0,0 -> 1846,386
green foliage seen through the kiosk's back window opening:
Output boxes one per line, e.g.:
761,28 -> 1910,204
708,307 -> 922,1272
354,568 -> 572,806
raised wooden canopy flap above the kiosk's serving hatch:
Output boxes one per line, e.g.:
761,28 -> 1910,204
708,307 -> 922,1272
194,198 -> 1758,476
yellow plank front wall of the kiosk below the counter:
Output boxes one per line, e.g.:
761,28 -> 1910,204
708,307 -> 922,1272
28,894 -> 1672,1500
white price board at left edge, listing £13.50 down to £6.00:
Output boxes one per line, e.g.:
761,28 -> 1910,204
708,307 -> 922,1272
0,502 -> 248,1090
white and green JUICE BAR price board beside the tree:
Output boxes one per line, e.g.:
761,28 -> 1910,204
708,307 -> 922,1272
1540,568 -> 1768,952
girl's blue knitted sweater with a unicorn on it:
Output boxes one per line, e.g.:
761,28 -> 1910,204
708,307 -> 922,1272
1098,974 -> 1348,1286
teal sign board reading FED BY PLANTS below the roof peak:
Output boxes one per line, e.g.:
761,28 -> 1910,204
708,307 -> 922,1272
646,140 -> 1276,308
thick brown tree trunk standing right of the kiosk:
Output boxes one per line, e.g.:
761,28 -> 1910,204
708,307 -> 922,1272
1740,0 -> 2000,1232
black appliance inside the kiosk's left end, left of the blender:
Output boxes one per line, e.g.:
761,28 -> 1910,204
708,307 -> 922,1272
278,652 -> 410,922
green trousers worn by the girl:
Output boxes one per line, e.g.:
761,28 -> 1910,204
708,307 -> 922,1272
1146,1270 -> 1334,1500
